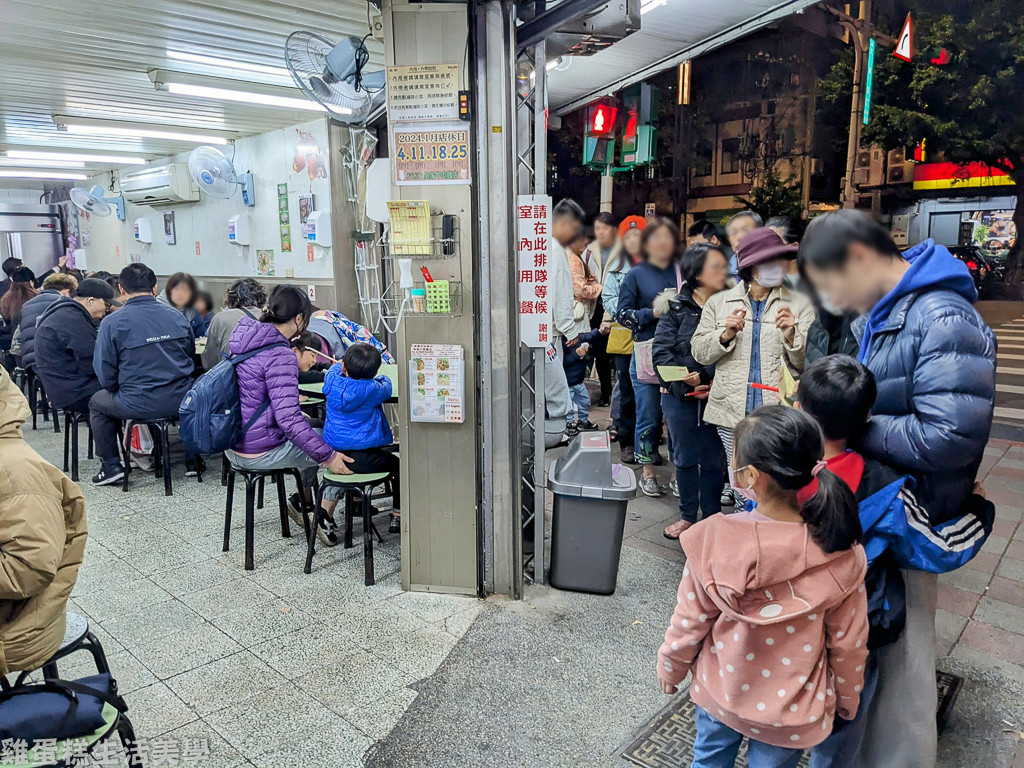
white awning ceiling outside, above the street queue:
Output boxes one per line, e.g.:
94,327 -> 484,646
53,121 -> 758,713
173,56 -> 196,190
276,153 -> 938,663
548,0 -> 818,114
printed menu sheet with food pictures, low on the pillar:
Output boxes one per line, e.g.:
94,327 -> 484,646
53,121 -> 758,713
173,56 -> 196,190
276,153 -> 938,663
409,344 -> 466,424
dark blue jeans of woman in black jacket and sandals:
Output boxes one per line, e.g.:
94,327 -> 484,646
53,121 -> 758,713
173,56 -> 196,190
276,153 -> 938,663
662,394 -> 725,522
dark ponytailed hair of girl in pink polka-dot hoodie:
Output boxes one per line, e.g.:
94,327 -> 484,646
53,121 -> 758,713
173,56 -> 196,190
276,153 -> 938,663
735,406 -> 863,553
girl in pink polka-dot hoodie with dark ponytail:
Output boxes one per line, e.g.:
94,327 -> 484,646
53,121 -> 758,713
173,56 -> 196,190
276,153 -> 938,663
657,406 -> 867,768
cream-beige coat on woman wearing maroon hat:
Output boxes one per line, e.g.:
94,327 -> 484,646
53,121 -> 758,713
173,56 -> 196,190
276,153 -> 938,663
690,283 -> 814,428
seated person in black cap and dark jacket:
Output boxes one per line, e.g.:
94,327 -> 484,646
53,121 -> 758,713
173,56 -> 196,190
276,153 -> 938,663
34,275 -> 121,413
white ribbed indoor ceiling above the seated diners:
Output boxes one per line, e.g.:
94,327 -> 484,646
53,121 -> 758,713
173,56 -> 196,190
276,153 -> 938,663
0,0 -> 383,176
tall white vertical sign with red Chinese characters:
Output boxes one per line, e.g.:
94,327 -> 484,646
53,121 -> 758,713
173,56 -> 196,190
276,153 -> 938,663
516,195 -> 551,349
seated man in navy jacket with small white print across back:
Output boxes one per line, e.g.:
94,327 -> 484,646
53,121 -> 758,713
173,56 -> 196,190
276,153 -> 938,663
89,263 -> 198,485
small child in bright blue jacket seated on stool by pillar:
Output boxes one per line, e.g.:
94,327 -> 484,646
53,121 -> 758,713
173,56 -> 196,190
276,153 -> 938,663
324,344 -> 401,534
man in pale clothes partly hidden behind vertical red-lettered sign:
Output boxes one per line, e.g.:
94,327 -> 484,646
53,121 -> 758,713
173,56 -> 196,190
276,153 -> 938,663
544,198 -> 584,447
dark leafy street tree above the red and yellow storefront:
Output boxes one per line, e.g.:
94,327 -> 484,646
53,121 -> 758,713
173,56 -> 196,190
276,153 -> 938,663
820,0 -> 1024,285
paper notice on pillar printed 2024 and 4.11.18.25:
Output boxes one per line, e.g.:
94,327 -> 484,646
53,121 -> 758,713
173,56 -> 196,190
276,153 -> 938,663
391,123 -> 470,186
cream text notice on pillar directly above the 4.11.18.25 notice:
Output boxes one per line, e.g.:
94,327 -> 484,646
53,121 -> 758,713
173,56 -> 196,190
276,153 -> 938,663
387,63 -> 459,123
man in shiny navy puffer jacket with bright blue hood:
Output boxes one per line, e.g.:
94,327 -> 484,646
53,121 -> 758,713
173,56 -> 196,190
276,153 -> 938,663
800,210 -> 995,768
